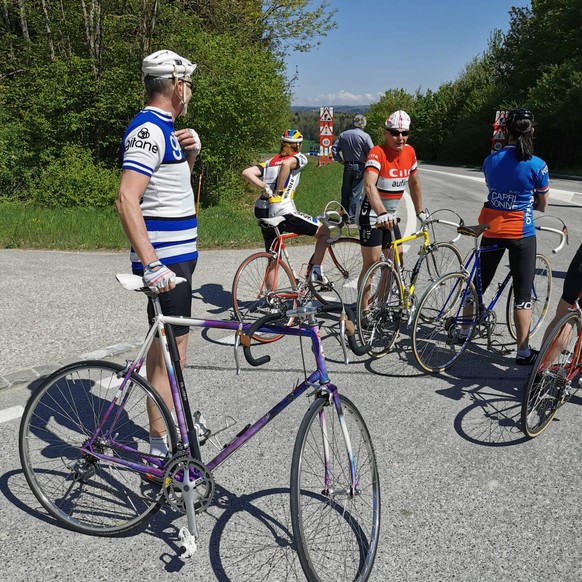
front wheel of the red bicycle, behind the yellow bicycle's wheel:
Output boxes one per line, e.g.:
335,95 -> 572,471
309,237 -> 362,306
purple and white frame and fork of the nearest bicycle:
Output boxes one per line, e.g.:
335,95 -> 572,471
81,286 -> 357,491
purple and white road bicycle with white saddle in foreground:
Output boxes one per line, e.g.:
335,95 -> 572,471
19,275 -> 380,581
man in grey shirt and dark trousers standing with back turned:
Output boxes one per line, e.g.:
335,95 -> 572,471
331,114 -> 374,222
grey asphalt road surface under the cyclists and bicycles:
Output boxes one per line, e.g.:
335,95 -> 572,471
0,166 -> 582,582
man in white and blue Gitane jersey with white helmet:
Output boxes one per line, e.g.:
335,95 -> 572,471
115,50 -> 201,456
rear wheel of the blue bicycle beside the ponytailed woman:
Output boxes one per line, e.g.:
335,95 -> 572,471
412,273 -> 479,374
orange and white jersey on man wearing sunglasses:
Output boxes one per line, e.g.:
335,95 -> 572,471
364,144 -> 418,214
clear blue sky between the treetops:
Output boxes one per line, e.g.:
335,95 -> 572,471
286,0 -> 530,106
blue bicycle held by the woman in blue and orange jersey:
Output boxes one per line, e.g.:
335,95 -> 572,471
412,223 -> 568,373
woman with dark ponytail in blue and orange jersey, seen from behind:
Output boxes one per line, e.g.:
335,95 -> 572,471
479,109 -> 550,365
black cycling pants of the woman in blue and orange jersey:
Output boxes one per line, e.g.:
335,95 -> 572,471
481,236 -> 536,305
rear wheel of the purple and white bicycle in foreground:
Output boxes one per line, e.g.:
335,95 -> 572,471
19,361 -> 177,536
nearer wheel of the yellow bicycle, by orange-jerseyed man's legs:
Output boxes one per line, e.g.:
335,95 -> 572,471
357,261 -> 406,358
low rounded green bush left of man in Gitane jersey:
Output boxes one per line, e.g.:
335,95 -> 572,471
31,145 -> 119,208
